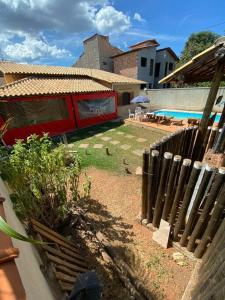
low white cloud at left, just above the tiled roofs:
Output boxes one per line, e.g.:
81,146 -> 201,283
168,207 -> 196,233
2,35 -> 71,61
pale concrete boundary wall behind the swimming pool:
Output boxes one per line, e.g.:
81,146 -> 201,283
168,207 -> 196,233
140,88 -> 225,112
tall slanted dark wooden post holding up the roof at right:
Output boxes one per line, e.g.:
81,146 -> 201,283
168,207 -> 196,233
195,59 -> 225,162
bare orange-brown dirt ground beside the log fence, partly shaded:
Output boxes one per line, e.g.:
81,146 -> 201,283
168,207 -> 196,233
78,168 -> 195,300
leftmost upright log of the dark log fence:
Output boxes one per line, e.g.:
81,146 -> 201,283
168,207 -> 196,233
141,150 -> 149,220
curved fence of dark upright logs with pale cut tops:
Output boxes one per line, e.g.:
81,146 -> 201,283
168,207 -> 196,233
141,127 -> 225,258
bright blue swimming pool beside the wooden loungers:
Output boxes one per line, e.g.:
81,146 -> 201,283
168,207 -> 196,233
154,109 -> 221,122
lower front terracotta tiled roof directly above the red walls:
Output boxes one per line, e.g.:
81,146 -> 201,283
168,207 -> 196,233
0,77 -> 111,98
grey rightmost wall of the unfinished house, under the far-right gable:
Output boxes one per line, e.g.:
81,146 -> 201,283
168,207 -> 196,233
154,49 -> 176,89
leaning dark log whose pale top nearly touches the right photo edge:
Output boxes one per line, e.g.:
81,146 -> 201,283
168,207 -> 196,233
187,168 -> 225,251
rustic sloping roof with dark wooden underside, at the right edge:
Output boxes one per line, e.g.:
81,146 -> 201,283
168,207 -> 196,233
159,37 -> 225,83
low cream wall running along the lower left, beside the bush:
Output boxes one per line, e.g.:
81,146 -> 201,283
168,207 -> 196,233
0,178 -> 55,300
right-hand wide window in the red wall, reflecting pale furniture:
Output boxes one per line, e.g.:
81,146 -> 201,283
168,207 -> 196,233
78,97 -> 116,119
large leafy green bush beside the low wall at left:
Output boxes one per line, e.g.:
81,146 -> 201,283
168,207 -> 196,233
1,135 -> 90,228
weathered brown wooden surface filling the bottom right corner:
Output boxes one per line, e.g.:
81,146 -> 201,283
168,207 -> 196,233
191,220 -> 225,300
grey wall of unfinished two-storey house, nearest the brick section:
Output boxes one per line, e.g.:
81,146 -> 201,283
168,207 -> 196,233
137,47 -> 156,88
